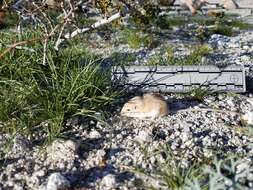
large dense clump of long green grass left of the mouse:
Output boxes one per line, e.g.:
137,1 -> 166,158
0,31 -> 115,140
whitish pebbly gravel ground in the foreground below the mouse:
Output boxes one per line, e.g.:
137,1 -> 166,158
0,91 -> 253,190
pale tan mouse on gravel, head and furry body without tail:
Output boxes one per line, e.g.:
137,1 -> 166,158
120,93 -> 169,119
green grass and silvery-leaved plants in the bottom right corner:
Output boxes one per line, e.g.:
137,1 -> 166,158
139,147 -> 252,190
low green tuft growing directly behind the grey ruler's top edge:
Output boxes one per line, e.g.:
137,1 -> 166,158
147,45 -> 212,65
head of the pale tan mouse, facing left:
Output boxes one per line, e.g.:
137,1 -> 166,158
120,96 -> 143,117
